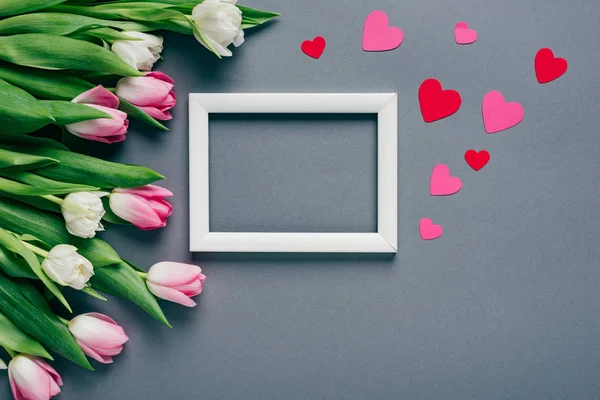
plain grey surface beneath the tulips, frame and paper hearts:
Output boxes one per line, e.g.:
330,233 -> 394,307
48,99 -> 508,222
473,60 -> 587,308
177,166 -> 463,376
0,0 -> 600,400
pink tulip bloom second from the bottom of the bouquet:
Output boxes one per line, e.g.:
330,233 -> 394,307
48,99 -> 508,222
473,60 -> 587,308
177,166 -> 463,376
69,313 -> 129,364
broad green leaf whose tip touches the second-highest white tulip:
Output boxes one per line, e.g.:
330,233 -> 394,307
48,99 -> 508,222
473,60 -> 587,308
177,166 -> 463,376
0,33 -> 143,76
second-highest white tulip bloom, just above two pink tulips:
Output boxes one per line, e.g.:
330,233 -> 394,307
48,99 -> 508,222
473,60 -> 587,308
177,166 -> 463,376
111,31 -> 163,71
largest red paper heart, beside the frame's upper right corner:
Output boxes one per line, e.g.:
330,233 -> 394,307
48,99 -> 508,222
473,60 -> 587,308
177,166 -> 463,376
419,78 -> 462,122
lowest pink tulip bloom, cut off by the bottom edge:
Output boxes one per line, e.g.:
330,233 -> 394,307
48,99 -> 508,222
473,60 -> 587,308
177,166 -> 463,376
8,354 -> 63,400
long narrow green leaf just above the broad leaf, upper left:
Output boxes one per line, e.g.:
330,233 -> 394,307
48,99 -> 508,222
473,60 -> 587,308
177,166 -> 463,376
0,12 -> 152,36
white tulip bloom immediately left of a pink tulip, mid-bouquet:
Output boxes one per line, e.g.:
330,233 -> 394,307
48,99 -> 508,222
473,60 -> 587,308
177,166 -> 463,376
61,192 -> 108,239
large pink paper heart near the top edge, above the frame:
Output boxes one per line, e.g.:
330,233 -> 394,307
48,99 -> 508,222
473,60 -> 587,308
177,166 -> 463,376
363,10 -> 404,51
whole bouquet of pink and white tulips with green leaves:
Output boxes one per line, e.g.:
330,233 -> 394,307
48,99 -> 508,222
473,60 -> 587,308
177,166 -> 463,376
0,0 -> 278,400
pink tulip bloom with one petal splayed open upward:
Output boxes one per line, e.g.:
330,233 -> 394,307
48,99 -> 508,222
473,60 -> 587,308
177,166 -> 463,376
65,85 -> 129,143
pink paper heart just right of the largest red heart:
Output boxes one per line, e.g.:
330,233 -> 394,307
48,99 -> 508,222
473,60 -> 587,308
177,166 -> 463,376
481,90 -> 525,133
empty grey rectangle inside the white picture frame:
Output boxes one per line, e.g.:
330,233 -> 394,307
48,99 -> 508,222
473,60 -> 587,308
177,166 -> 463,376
209,113 -> 377,232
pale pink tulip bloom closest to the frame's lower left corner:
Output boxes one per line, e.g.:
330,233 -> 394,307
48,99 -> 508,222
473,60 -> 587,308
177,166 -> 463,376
146,261 -> 206,307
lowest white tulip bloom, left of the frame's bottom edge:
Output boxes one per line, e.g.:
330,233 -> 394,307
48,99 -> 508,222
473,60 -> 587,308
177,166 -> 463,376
42,244 -> 94,290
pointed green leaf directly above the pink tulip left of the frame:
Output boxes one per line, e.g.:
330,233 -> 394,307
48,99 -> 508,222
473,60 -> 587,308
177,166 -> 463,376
7,146 -> 164,189
